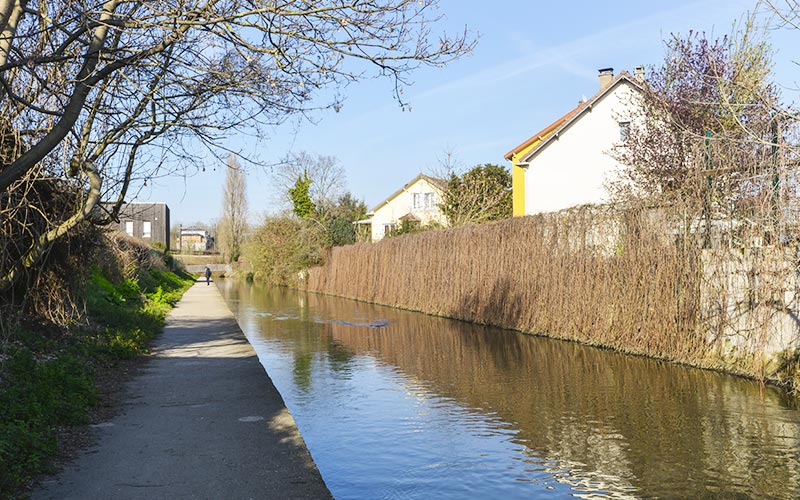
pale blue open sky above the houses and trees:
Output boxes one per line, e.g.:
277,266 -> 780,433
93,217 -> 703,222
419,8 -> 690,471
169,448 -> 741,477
141,0 -> 800,226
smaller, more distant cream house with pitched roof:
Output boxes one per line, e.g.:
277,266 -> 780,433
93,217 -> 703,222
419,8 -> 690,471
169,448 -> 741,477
356,174 -> 447,241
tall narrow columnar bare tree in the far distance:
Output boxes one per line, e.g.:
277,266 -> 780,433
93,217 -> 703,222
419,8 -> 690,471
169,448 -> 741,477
218,153 -> 247,262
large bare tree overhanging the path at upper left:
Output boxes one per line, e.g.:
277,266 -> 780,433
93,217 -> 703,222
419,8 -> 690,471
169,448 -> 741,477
0,0 -> 472,288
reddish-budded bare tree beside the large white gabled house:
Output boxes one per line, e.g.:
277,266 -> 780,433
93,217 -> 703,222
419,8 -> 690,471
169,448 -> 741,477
612,33 -> 778,216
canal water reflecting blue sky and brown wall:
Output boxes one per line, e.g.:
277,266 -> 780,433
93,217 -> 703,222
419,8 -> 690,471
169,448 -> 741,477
219,280 -> 800,500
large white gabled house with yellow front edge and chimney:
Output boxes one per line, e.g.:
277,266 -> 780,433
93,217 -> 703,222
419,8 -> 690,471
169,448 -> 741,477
505,67 -> 644,216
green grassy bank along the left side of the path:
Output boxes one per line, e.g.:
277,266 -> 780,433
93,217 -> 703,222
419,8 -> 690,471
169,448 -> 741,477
0,265 -> 193,499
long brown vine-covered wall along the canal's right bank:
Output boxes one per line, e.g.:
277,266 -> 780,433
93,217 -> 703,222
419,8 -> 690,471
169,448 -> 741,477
308,209 -> 795,386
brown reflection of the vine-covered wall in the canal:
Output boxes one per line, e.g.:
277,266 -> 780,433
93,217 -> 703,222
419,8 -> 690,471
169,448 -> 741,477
307,294 -> 800,498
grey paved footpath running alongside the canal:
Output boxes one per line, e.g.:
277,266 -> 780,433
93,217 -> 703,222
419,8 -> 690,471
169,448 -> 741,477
32,282 -> 332,499
